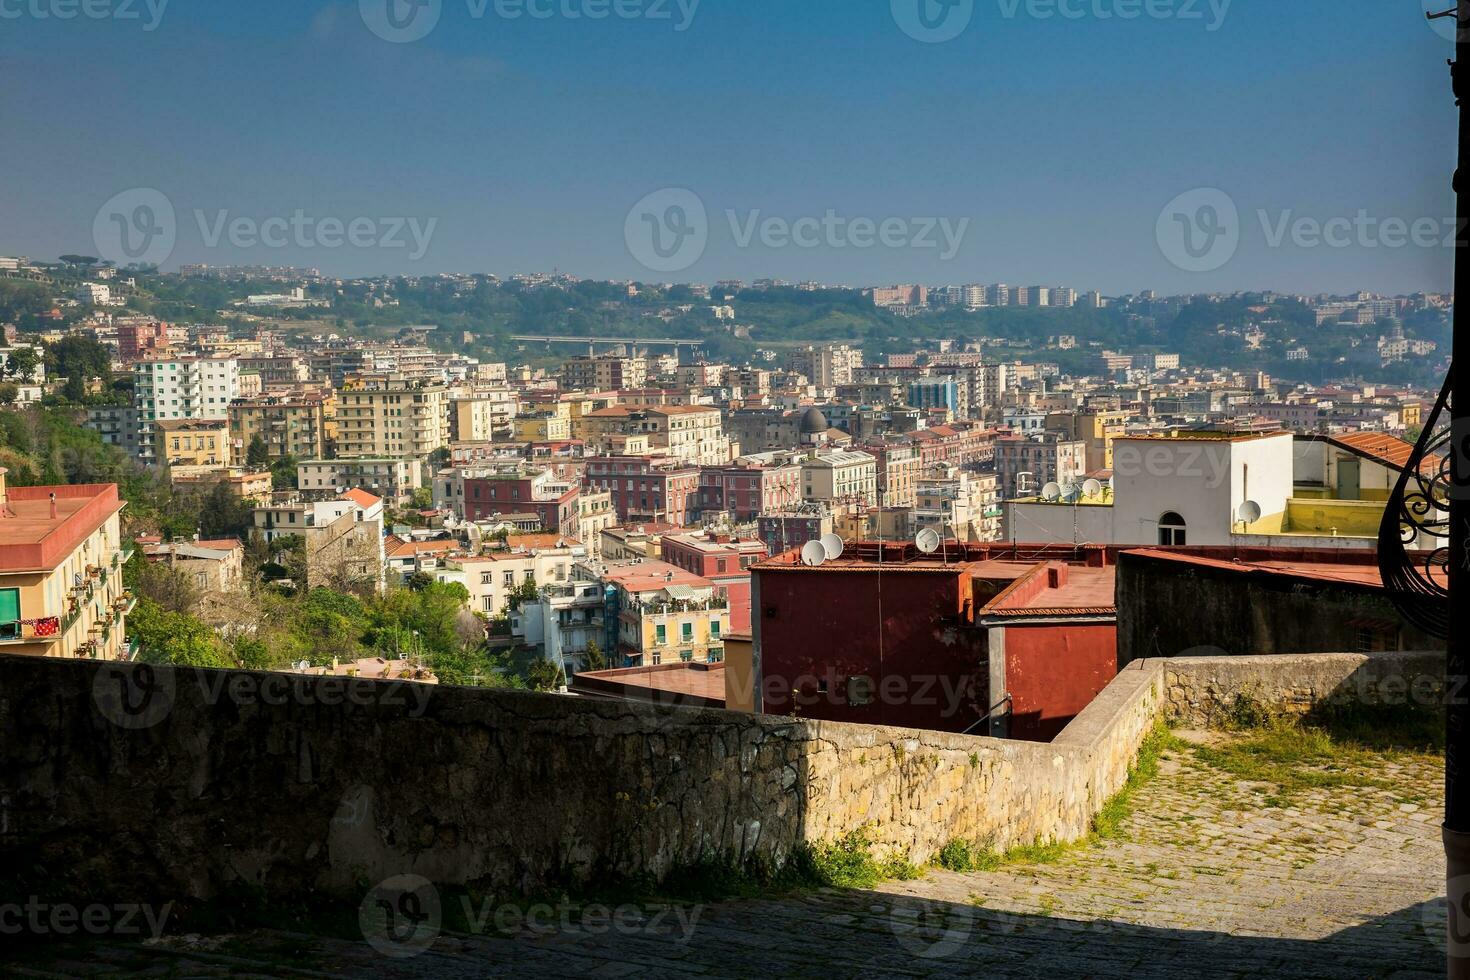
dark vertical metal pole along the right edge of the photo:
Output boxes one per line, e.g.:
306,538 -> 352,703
1444,0 -> 1470,980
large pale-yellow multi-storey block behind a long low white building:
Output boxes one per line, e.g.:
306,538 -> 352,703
337,378 -> 450,458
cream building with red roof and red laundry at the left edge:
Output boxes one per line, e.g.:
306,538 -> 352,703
0,467 -> 132,660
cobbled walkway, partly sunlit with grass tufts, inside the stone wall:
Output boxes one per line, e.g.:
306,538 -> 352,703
12,731 -> 1444,980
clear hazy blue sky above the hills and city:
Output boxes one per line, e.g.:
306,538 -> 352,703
0,0 -> 1455,295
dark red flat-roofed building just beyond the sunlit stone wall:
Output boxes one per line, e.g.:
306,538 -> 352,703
751,542 -> 1117,741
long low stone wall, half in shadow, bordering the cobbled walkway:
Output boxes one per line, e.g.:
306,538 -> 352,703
0,657 -> 1442,901
